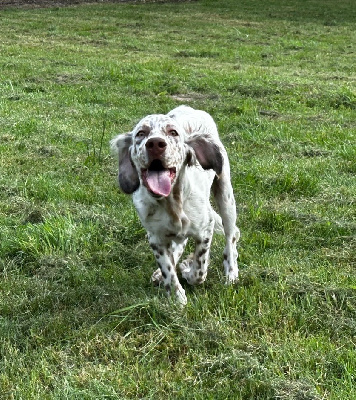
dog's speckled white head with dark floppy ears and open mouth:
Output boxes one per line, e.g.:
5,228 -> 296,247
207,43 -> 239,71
111,114 -> 223,197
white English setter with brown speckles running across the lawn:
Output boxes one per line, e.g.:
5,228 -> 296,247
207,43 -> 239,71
111,106 -> 240,305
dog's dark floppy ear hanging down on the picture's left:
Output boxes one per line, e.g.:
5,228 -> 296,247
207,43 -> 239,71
110,133 -> 140,194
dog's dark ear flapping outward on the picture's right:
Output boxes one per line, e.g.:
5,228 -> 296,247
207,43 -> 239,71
186,134 -> 224,175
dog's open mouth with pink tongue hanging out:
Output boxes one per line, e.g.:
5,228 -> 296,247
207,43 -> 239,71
142,160 -> 176,197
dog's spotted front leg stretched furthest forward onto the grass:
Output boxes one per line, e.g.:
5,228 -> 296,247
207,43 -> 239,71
149,235 -> 187,305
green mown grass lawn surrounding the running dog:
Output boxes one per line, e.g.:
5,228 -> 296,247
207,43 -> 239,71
0,0 -> 356,400
